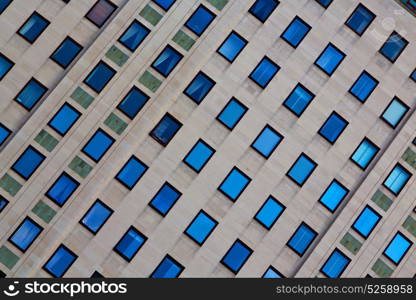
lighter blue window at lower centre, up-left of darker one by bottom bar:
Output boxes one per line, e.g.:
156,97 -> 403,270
185,210 -> 218,245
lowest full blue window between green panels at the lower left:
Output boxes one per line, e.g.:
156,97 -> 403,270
9,217 -> 43,252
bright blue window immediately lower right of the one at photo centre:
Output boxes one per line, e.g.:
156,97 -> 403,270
218,167 -> 251,202
